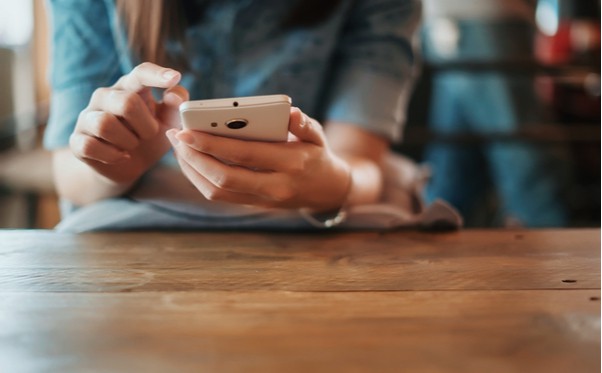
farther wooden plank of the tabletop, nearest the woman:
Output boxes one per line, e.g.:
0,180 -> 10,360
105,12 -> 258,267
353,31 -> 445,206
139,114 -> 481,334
0,230 -> 600,292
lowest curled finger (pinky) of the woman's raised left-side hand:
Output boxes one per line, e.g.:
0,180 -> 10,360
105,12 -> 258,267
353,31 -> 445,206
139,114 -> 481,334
69,134 -> 131,164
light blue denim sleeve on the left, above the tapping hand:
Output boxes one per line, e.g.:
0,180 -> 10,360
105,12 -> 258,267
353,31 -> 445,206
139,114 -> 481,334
44,0 -> 122,149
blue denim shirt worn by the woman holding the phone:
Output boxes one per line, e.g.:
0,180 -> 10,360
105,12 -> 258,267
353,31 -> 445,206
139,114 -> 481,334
44,0 -> 421,149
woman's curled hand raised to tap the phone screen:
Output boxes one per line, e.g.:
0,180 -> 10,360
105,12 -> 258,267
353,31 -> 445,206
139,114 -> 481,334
69,62 -> 189,186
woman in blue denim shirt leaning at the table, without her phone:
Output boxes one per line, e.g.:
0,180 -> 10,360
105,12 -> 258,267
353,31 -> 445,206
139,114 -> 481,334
45,0 -> 420,231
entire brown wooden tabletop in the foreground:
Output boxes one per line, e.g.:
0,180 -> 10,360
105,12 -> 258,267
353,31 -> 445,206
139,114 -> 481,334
0,229 -> 600,373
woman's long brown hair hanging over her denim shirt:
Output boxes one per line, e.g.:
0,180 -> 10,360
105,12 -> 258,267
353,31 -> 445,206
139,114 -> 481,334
116,0 -> 341,68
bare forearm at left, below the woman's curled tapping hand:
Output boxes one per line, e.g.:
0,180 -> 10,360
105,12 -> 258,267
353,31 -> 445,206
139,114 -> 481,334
53,149 -> 134,206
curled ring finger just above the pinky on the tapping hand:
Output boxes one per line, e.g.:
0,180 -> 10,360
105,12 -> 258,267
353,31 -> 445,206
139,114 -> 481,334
81,111 -> 140,151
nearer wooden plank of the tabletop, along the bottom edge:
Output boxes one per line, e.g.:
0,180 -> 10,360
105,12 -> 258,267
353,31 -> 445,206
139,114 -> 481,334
0,290 -> 600,372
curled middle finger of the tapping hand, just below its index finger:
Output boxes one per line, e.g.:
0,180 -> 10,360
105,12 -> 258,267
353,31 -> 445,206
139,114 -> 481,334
88,88 -> 159,139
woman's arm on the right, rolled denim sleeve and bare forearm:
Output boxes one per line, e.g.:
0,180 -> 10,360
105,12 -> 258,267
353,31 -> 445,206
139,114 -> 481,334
314,0 -> 421,204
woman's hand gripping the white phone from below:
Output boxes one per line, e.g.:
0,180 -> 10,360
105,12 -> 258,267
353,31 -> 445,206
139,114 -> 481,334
167,108 -> 351,211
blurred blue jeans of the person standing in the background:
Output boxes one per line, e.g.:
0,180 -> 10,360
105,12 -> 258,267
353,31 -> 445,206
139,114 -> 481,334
423,22 -> 567,227
